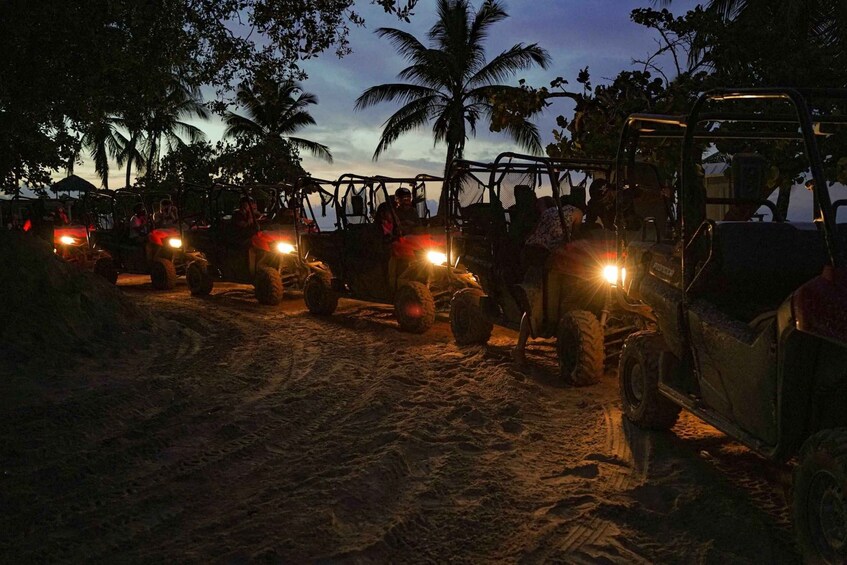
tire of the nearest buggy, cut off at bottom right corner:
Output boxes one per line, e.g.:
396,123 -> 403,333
791,428 -> 847,564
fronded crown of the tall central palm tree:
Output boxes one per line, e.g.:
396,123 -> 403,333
356,0 -> 550,183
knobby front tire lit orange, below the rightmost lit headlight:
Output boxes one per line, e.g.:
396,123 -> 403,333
556,310 -> 604,386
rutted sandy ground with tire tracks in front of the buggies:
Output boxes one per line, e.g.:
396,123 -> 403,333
0,277 -> 798,563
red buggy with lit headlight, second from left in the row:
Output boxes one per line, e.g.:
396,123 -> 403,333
84,189 -> 192,290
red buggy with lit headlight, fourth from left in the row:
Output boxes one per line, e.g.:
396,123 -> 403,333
303,174 -> 478,333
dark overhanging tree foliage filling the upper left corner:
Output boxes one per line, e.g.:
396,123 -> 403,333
0,0 -> 416,190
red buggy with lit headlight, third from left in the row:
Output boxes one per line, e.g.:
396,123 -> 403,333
181,184 -> 318,305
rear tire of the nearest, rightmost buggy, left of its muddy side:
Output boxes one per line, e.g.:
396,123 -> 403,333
618,331 -> 681,430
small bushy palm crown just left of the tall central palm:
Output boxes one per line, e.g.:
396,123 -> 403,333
224,79 -> 332,163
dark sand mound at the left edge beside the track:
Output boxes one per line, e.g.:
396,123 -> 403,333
0,232 -> 167,370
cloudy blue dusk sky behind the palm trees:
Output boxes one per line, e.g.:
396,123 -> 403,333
66,0 -> 697,187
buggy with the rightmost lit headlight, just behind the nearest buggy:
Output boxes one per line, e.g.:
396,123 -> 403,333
448,153 -> 672,386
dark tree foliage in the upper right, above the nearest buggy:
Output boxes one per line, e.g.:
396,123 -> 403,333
493,0 -> 847,183
